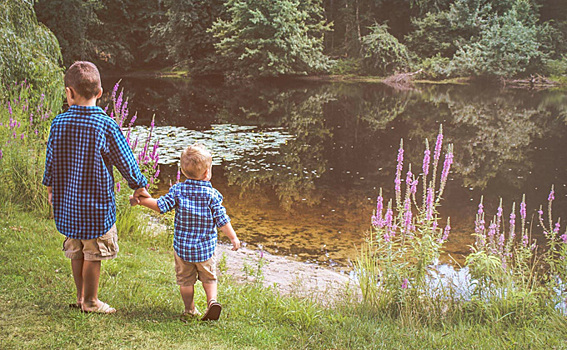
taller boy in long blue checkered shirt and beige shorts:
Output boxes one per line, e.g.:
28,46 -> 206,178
43,61 -> 149,314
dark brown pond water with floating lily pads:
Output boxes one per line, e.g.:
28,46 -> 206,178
102,77 -> 567,270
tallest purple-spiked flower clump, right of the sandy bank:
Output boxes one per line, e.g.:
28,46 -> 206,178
356,128 -> 453,316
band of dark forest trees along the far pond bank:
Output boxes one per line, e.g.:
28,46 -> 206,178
35,0 -> 567,79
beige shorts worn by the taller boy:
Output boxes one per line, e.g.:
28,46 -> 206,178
63,225 -> 118,261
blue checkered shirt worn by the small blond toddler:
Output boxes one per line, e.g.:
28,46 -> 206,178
157,179 -> 230,262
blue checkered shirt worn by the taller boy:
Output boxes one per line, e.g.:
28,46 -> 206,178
43,105 -> 148,239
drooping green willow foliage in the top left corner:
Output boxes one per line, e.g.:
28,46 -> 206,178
0,0 -> 63,98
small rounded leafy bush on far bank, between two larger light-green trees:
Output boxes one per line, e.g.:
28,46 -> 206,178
362,24 -> 410,75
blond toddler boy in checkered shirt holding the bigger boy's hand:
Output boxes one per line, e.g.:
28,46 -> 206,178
130,144 -> 240,322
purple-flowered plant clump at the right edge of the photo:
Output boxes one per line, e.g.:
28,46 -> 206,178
466,186 -> 567,318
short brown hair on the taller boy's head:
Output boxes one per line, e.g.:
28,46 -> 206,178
65,61 -> 102,99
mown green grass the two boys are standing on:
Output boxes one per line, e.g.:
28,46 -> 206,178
0,206 -> 567,349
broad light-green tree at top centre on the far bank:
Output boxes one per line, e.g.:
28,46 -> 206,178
211,0 -> 329,77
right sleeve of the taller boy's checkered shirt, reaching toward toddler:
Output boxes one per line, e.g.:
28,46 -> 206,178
107,123 -> 148,190
